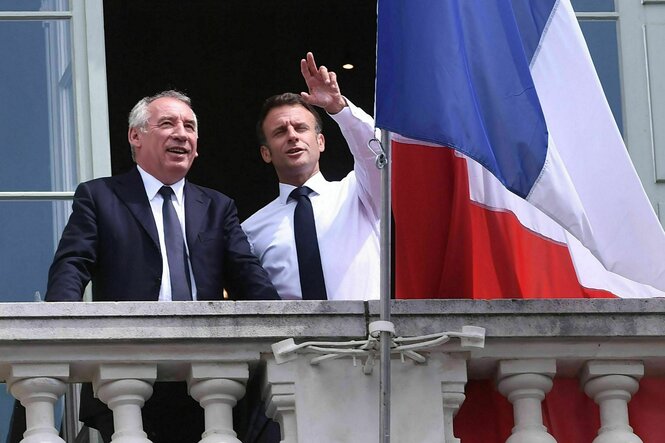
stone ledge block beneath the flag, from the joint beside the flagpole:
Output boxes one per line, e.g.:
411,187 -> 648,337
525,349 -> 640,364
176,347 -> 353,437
369,299 -> 665,340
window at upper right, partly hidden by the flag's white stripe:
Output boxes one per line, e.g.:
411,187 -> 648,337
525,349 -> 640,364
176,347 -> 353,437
572,0 -> 665,226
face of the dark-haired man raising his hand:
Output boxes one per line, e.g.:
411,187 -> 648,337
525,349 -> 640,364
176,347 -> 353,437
261,105 -> 325,186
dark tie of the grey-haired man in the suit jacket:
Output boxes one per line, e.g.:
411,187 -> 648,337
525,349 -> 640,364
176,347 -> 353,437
159,186 -> 192,301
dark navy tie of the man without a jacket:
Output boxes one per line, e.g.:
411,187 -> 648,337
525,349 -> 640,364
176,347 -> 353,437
289,186 -> 328,300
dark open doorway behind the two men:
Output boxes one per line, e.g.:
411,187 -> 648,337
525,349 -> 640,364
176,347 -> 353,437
104,0 -> 376,220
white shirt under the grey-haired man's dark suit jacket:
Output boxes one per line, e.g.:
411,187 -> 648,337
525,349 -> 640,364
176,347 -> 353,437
136,165 -> 196,301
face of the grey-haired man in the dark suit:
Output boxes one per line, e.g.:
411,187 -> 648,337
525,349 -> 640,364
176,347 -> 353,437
128,97 -> 198,185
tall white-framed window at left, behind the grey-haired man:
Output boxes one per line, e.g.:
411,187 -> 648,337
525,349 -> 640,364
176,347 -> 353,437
0,0 -> 110,441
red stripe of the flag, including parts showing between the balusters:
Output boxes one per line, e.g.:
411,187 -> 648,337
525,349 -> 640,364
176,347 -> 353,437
392,142 -> 665,443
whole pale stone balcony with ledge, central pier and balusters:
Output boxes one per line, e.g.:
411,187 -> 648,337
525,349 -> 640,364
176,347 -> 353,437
0,299 -> 665,443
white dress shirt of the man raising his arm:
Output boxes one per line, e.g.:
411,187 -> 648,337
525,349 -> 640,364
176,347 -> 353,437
242,100 -> 381,300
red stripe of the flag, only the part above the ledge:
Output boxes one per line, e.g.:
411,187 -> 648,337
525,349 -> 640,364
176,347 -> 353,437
392,142 -> 614,299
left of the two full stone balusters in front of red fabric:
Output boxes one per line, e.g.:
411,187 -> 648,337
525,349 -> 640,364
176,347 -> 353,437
497,359 -> 556,443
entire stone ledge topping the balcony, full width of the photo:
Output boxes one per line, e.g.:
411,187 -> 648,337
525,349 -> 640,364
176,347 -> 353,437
0,299 -> 665,344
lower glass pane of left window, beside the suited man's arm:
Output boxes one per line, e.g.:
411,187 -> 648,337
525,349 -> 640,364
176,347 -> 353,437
0,201 -> 72,302
